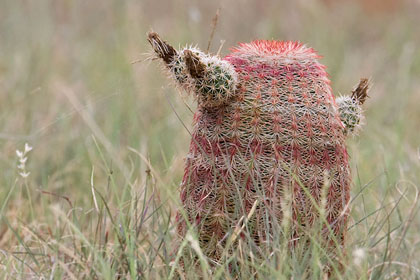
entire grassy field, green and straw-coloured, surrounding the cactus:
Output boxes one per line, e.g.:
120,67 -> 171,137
0,0 -> 420,279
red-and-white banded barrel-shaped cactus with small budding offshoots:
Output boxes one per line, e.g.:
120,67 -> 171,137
148,32 -> 368,259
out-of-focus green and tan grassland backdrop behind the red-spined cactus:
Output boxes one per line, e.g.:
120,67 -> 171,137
0,0 -> 420,272
